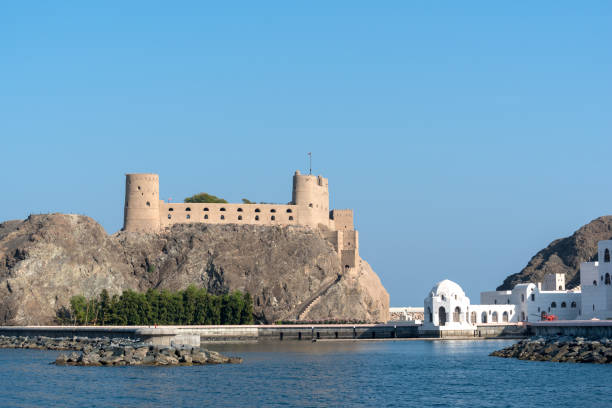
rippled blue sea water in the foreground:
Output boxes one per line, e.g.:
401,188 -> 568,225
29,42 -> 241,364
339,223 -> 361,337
0,341 -> 612,407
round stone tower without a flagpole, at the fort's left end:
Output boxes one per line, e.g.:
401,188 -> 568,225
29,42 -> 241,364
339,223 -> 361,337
123,173 -> 160,232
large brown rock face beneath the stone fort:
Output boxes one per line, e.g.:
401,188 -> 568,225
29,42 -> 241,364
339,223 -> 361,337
0,214 -> 389,325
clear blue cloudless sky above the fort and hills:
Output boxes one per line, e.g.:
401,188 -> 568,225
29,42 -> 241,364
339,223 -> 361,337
0,1 -> 612,306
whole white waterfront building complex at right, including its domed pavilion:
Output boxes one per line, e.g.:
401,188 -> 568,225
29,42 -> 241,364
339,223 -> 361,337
420,240 -> 612,332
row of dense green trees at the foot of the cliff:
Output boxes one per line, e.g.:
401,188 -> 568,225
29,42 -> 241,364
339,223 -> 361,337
58,286 -> 253,326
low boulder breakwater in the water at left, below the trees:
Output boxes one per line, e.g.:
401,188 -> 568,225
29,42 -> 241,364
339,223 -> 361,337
0,336 -> 242,366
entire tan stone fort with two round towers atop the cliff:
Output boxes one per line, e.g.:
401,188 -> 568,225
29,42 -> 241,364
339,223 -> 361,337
123,171 -> 359,269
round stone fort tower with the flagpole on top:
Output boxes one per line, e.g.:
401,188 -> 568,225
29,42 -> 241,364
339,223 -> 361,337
292,171 -> 329,227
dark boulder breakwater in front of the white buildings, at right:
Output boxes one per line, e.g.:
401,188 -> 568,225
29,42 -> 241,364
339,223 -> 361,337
490,337 -> 612,364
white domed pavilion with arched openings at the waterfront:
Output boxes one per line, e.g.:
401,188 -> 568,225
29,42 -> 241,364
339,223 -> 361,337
420,279 -> 476,334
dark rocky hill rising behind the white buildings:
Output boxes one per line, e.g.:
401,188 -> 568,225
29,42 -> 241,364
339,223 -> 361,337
497,216 -> 612,290
